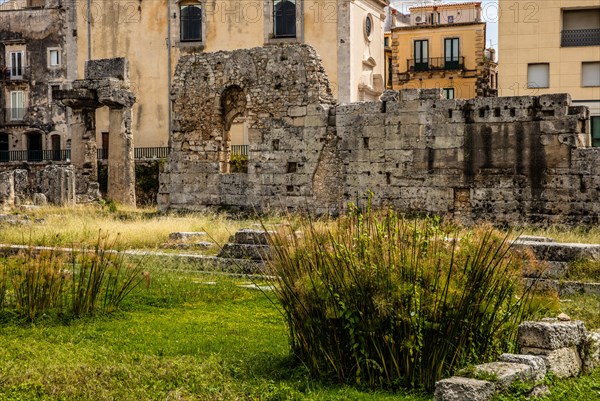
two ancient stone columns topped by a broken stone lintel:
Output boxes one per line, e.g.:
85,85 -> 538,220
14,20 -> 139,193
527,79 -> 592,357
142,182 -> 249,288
52,58 -> 135,206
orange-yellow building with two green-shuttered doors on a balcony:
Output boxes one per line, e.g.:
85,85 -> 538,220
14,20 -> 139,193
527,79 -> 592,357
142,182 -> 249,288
392,2 -> 497,99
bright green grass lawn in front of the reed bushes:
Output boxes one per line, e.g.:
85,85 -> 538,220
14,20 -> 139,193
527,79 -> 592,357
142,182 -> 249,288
0,273 -> 430,401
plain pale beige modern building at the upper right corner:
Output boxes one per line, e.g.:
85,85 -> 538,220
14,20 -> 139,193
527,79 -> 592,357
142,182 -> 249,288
498,0 -> 600,146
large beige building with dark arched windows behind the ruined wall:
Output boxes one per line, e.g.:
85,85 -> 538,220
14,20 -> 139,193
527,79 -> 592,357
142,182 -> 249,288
77,0 -> 388,148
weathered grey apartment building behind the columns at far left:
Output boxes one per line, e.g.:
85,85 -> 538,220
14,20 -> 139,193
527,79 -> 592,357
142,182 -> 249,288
0,0 -> 76,162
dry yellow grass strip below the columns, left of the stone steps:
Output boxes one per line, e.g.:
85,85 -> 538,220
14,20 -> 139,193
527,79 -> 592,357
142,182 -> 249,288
0,205 -> 256,249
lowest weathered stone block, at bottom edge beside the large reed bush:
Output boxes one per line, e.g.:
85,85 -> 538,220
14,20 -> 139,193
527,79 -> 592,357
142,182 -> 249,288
434,377 -> 496,401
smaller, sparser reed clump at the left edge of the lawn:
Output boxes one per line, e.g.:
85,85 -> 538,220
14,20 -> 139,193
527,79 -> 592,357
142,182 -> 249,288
0,235 -> 145,321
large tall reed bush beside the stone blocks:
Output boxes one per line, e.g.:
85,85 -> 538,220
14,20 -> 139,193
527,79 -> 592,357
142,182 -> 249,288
268,208 -> 529,390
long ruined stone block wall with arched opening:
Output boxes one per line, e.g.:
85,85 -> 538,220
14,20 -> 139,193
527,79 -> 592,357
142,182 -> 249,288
158,45 -> 600,223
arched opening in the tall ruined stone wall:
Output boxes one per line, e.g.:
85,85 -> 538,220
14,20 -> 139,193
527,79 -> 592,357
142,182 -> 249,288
219,85 -> 248,173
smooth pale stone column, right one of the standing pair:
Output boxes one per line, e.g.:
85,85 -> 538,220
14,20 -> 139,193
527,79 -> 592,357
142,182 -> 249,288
107,107 -> 135,206
